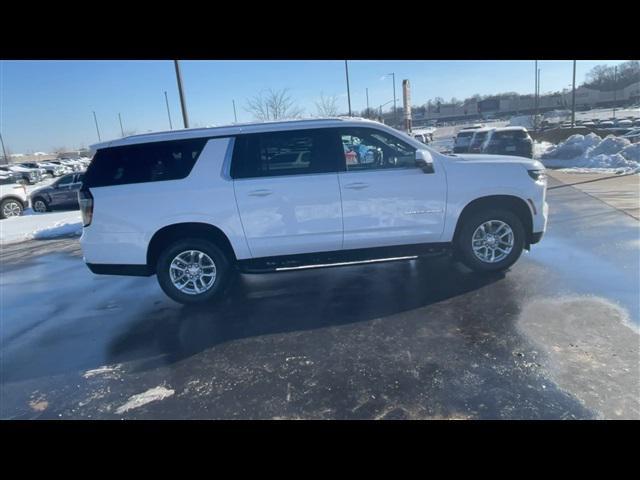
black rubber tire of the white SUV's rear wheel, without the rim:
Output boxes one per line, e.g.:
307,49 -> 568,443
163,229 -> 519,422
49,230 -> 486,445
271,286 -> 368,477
156,238 -> 232,305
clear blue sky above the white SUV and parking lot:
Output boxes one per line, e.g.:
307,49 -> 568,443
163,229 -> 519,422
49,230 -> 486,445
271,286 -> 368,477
0,60 -> 620,153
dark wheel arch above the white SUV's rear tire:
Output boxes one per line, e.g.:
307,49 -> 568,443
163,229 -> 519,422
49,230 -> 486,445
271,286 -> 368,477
147,222 -> 236,273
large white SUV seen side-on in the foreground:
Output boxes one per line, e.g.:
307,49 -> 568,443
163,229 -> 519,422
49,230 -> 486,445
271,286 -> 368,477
79,119 -> 547,303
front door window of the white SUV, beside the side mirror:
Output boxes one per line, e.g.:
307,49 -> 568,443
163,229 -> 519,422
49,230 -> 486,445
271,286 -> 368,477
340,128 -> 416,171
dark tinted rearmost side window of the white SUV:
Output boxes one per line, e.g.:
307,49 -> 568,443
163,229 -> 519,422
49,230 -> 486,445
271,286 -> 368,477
83,138 -> 207,187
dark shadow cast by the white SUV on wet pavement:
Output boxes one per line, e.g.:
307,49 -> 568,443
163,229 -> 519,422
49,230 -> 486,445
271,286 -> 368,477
109,257 -> 504,370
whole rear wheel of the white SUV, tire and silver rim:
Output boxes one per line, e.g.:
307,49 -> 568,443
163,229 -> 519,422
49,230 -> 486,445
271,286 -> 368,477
156,238 -> 230,304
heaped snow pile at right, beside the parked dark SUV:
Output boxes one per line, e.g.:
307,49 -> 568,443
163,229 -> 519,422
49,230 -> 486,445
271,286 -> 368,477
534,133 -> 640,173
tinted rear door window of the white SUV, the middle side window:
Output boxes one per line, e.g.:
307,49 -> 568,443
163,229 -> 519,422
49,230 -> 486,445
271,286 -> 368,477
231,129 -> 340,178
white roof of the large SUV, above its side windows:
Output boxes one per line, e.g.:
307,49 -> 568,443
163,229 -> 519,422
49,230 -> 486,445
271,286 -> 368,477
91,117 -> 388,150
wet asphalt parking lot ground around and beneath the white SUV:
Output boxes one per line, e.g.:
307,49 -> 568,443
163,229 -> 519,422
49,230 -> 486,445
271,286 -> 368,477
0,179 -> 640,419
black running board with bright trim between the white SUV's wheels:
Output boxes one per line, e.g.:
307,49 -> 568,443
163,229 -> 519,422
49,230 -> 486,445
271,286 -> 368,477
238,243 -> 451,273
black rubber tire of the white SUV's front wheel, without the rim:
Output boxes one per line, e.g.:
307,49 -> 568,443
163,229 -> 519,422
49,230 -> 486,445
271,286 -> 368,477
456,209 -> 525,272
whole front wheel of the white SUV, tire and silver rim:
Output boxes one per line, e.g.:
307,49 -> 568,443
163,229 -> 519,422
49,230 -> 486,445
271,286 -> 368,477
457,209 -> 525,272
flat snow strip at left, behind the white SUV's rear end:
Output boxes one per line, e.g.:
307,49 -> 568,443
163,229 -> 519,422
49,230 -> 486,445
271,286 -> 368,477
0,210 -> 82,245
